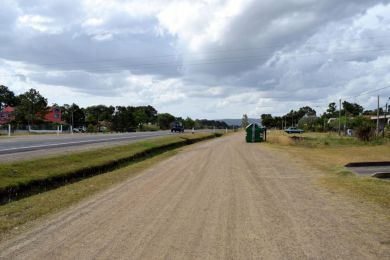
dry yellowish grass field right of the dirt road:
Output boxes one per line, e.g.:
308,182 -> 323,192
267,131 -> 390,209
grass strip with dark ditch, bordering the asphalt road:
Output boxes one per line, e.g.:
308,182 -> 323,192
0,133 -> 216,204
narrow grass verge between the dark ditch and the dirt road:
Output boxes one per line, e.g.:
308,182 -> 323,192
0,150 -> 177,241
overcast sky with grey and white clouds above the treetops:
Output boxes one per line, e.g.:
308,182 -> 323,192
0,0 -> 390,119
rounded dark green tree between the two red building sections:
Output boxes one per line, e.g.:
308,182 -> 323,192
15,89 -> 49,125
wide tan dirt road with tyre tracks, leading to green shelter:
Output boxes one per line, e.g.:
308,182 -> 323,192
0,134 -> 390,259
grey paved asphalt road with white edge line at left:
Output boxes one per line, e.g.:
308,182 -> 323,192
0,131 -> 171,155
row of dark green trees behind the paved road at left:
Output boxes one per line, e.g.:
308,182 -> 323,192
0,85 -> 228,132
